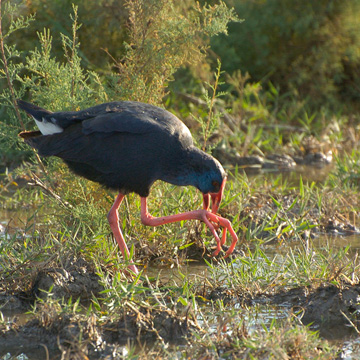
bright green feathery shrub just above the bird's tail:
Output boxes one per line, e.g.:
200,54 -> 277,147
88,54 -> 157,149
21,6 -> 107,111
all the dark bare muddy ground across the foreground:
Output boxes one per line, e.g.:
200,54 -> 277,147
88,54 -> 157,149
0,246 -> 360,359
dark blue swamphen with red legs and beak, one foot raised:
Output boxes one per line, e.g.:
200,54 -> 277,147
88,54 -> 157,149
17,100 -> 238,274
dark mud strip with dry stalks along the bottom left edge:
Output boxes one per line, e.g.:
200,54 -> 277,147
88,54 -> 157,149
0,303 -> 199,359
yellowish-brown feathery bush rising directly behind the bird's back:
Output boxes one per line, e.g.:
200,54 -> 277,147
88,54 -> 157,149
106,0 -> 238,104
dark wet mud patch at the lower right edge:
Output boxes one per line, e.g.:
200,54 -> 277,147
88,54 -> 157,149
208,283 -> 360,340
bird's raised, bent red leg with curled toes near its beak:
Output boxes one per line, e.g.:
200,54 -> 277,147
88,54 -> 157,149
141,197 -> 238,257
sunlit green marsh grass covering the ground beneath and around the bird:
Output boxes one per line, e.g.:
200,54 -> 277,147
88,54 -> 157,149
0,157 -> 359,359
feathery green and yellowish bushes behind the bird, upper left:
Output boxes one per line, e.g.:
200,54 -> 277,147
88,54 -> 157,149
0,0 -> 236,162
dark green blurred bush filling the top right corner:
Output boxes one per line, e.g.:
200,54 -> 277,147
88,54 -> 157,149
211,0 -> 360,106
